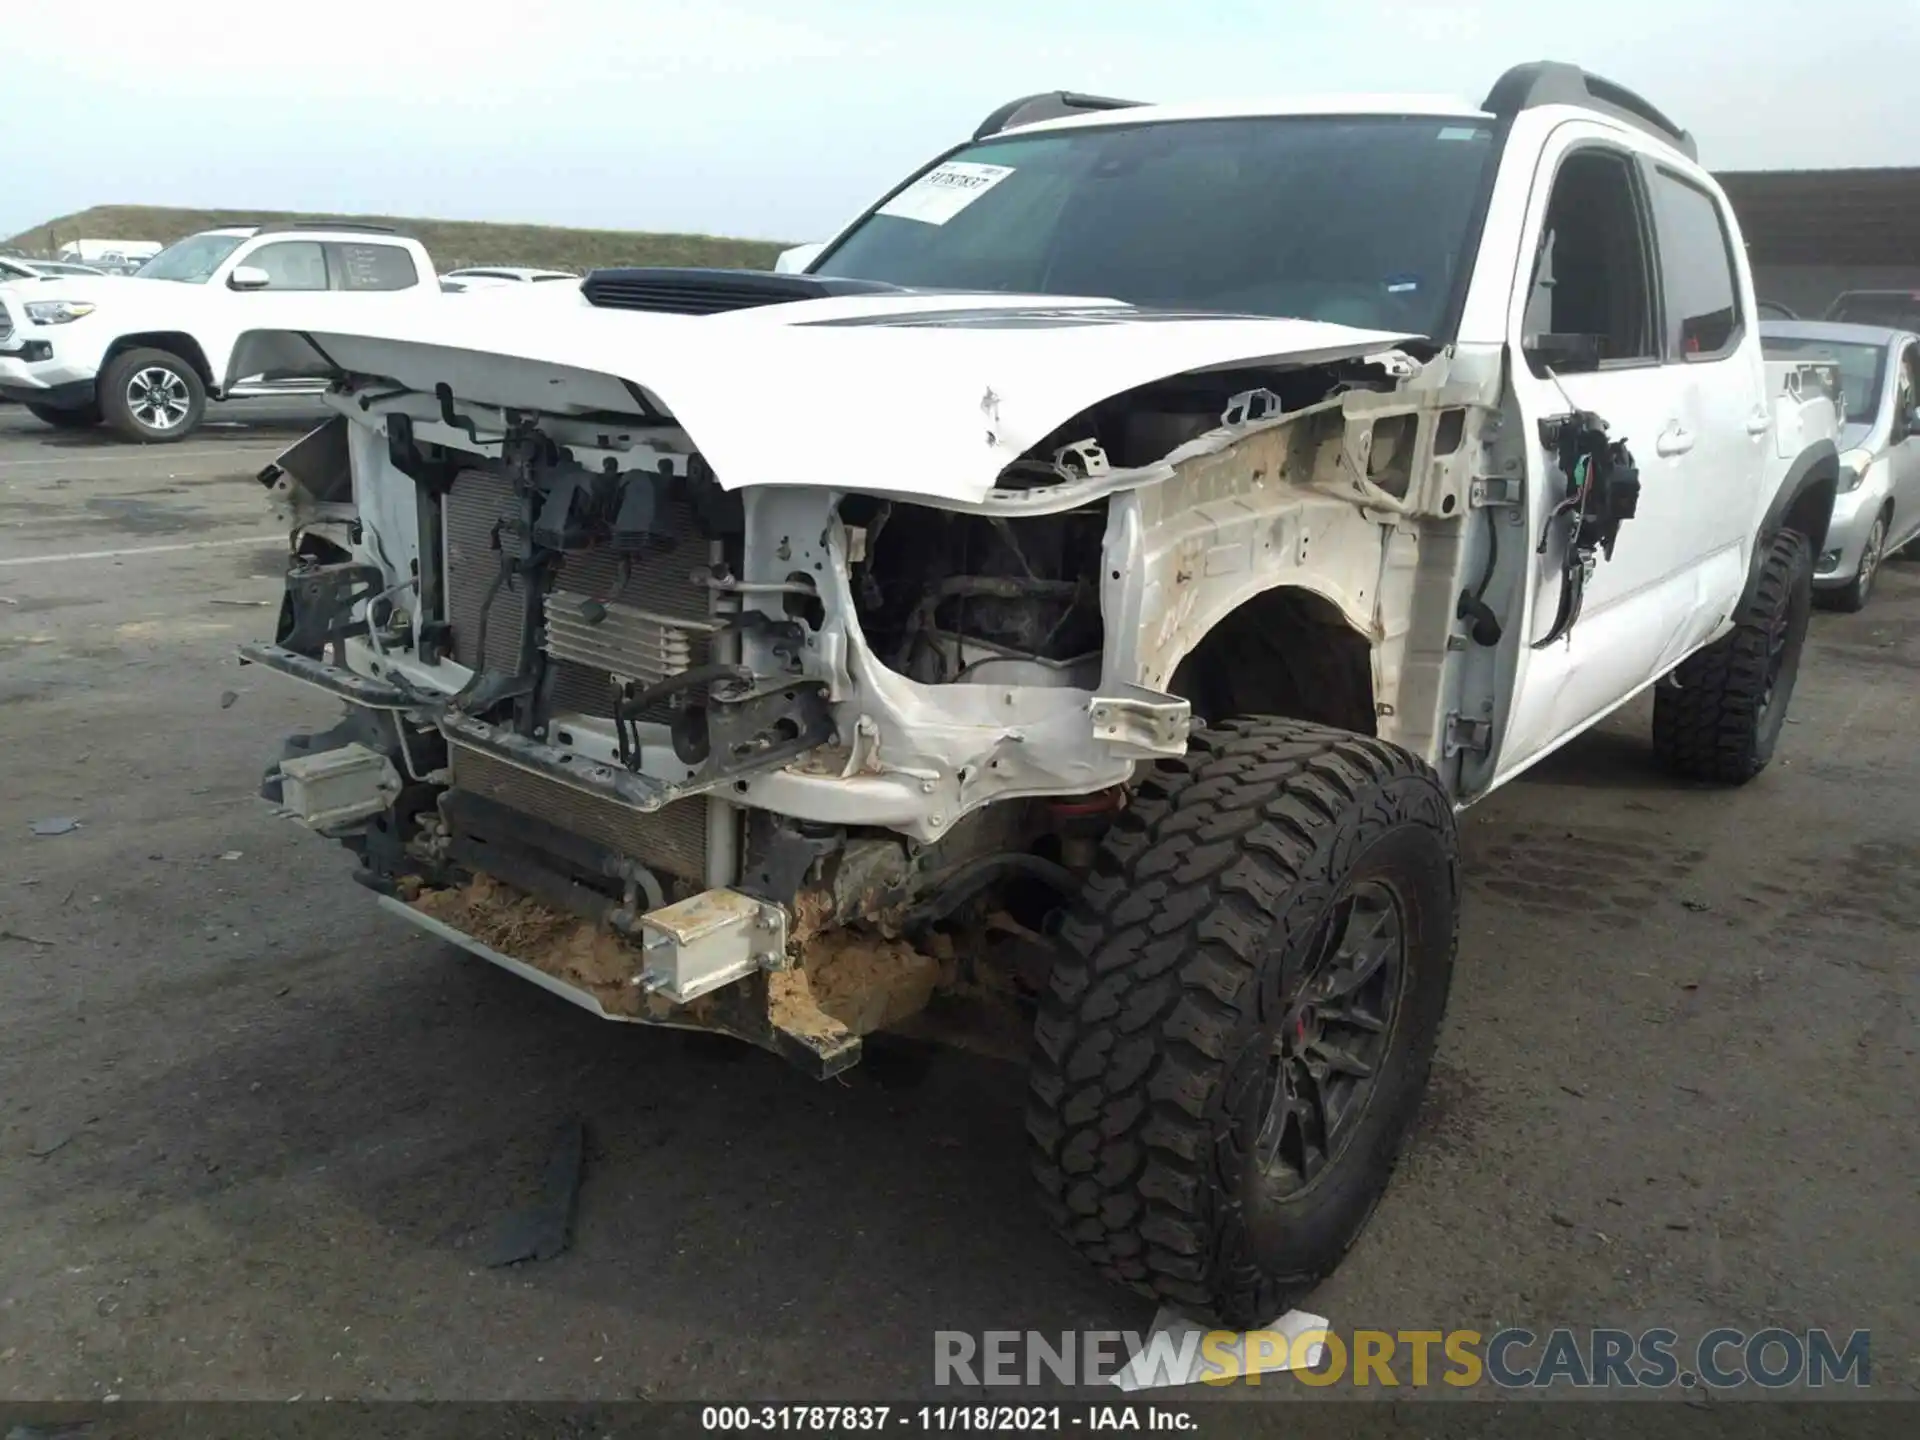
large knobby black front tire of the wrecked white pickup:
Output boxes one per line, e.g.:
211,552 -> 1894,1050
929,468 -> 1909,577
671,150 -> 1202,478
1027,718 -> 1459,1329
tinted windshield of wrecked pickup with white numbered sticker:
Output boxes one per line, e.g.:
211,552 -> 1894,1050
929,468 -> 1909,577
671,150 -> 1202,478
812,115 -> 1496,338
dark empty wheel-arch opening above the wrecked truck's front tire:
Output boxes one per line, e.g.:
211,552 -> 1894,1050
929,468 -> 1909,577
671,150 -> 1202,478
1169,586 -> 1379,735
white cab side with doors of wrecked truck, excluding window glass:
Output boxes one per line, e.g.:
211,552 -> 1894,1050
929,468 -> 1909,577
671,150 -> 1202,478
1461,106 -> 1837,785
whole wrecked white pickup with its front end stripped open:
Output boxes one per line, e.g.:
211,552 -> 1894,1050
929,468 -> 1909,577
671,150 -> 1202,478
234,65 -> 1839,1327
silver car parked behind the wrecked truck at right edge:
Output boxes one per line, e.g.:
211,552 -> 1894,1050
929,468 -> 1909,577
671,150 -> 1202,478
1761,321 -> 1920,611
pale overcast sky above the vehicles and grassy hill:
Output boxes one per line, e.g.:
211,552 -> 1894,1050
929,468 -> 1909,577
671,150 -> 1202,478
0,0 -> 1920,240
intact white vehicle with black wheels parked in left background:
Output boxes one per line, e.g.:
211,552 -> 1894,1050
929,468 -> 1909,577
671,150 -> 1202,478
0,221 -> 440,442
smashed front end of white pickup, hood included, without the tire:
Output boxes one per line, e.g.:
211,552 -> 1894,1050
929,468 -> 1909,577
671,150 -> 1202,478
236,275 -> 1517,1075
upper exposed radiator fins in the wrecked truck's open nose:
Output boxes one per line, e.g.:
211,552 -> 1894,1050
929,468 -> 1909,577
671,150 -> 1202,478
442,470 -> 714,716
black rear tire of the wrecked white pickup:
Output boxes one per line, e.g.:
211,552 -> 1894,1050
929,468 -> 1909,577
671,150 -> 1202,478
1653,530 -> 1812,785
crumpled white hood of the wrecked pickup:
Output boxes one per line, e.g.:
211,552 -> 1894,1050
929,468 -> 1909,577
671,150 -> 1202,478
227,292 -> 1413,501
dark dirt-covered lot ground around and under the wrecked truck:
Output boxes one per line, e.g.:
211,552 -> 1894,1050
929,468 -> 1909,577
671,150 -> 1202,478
0,407 -> 1920,1400
